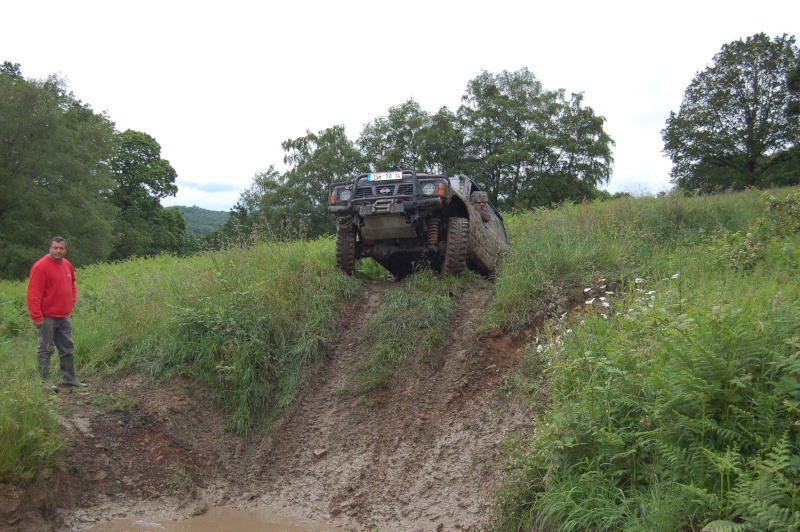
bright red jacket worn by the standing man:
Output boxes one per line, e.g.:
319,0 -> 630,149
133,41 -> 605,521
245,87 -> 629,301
28,255 -> 78,321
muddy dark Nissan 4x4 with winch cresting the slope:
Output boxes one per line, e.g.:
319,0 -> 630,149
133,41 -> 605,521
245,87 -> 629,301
328,170 -> 508,279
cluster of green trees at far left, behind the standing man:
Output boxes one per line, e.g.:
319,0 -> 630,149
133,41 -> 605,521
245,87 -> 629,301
0,62 -> 199,279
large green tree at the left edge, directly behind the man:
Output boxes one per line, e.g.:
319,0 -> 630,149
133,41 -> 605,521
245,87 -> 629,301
0,62 -> 115,278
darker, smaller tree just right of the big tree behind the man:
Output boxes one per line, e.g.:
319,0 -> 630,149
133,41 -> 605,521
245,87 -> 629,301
109,129 -> 184,260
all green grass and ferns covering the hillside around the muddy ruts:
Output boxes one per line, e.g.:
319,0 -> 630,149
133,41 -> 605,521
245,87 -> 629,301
0,190 -> 800,530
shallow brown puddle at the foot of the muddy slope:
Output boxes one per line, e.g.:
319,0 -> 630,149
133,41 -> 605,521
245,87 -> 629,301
87,508 -> 334,532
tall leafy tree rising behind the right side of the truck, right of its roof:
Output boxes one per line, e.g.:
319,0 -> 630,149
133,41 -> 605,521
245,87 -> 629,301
458,69 -> 614,209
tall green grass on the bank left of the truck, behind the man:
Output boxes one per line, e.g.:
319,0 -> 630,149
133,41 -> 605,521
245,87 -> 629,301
0,240 -> 357,447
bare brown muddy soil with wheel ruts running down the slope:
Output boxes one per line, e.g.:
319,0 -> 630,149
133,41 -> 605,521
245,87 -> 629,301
0,282 -> 548,531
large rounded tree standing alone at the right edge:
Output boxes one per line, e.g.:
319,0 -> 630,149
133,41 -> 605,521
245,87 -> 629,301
661,33 -> 800,192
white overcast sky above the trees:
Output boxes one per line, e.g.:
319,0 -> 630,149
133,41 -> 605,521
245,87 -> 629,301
0,0 -> 800,211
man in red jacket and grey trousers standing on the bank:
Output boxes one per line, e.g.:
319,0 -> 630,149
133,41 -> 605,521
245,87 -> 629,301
27,236 -> 86,393
